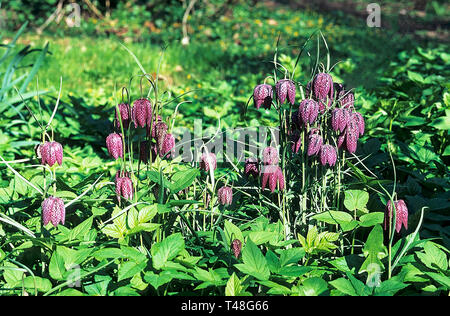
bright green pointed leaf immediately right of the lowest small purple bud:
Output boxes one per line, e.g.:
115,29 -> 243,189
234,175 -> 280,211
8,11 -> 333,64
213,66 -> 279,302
235,238 -> 270,280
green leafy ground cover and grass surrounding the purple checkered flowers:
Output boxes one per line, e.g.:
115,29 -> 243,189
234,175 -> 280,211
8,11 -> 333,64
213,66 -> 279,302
0,2 -> 450,295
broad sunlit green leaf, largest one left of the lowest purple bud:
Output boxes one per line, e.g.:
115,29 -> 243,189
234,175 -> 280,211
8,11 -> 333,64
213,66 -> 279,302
151,233 -> 184,270
